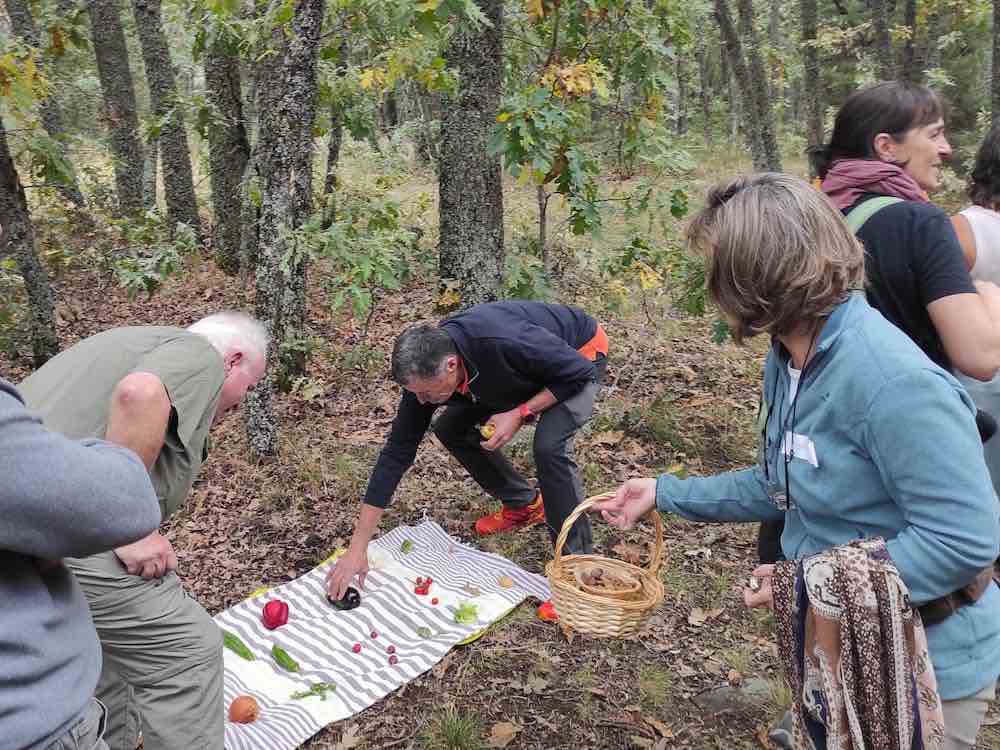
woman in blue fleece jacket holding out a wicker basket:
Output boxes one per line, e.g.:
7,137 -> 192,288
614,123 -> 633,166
598,174 -> 1000,748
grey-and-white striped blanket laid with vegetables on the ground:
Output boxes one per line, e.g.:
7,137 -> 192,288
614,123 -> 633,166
215,521 -> 549,750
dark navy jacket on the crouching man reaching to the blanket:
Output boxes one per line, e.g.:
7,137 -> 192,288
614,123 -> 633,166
365,301 -> 597,508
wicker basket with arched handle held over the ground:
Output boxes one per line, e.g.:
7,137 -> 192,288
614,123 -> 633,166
545,492 -> 664,638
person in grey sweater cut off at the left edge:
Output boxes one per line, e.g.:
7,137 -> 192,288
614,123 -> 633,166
0,379 -> 160,750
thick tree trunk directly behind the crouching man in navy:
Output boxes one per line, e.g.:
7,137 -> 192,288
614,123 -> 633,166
438,0 -> 504,307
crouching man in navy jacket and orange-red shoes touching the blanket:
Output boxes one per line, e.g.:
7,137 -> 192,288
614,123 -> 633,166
327,301 -> 608,619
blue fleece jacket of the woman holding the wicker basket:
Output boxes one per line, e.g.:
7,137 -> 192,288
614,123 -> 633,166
656,292 -> 1000,700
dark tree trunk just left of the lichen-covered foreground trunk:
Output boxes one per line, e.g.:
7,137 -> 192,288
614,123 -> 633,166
205,39 -> 250,275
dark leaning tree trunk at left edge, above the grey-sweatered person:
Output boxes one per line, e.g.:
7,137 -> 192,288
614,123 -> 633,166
0,120 -> 59,367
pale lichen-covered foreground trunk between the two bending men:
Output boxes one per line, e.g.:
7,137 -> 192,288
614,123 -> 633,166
245,0 -> 324,456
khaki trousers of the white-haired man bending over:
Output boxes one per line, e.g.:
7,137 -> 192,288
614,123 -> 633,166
66,552 -> 224,750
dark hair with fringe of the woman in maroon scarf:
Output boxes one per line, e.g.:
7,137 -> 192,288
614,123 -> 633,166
806,81 -> 944,178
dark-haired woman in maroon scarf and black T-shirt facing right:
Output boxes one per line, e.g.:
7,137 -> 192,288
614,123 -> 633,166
757,81 -> 1000,562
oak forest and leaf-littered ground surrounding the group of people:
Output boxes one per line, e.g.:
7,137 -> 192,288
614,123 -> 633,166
0,0 -> 1000,750
